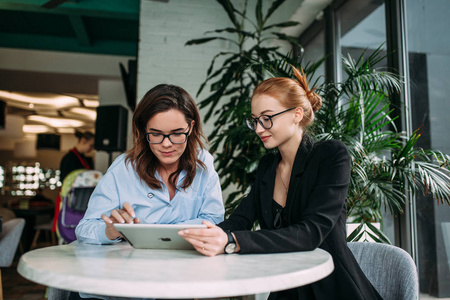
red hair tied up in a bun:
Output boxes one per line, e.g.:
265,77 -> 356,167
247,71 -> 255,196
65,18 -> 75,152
252,66 -> 322,130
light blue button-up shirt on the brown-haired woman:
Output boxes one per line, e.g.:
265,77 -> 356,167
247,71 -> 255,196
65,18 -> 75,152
75,149 -> 229,244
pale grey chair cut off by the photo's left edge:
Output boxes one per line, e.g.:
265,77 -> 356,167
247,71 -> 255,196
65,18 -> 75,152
0,218 -> 25,299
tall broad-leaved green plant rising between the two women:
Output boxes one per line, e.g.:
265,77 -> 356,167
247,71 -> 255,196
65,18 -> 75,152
186,0 -> 304,214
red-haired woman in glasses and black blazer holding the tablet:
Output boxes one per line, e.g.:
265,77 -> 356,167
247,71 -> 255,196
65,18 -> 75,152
179,68 -> 381,300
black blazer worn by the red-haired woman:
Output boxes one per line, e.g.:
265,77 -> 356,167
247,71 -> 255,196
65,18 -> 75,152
218,135 -> 381,300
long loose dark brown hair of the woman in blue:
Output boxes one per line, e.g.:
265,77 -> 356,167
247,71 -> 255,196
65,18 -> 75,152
125,84 -> 206,189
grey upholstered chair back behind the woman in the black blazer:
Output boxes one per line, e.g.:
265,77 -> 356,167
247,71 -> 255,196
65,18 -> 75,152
347,242 -> 419,300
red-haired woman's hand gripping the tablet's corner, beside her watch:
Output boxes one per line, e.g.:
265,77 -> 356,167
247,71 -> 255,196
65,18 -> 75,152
178,221 -> 239,256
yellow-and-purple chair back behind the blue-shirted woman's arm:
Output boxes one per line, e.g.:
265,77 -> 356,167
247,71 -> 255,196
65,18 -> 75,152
57,169 -> 103,243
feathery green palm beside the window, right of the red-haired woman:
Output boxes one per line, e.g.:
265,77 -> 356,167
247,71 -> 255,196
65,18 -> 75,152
313,48 -> 450,243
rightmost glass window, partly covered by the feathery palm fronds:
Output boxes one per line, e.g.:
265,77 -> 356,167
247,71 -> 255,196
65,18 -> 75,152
405,0 -> 450,297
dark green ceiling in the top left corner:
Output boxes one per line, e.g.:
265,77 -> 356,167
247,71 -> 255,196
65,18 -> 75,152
0,0 -> 140,56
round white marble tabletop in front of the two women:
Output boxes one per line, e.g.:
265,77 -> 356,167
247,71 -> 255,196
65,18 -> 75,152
17,242 -> 334,299
